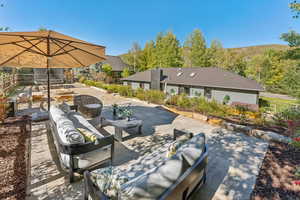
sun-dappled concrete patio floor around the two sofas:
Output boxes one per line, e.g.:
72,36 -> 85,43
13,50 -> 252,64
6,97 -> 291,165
28,85 -> 268,200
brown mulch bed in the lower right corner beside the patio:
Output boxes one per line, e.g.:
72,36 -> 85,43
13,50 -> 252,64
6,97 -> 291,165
251,143 -> 300,200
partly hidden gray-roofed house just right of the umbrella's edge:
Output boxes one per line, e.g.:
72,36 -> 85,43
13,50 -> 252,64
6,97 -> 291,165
99,55 -> 130,81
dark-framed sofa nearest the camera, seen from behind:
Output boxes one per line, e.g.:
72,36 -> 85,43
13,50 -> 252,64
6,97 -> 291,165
84,129 -> 208,200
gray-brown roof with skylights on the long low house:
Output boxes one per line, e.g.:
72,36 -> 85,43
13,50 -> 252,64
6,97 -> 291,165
122,67 -> 264,91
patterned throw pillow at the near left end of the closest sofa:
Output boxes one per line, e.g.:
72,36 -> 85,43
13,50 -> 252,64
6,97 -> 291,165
91,166 -> 128,200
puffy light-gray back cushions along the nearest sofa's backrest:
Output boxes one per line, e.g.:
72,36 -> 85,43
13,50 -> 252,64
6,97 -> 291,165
121,134 -> 205,200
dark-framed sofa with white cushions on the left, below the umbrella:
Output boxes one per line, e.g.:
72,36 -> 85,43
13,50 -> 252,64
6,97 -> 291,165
49,103 -> 114,182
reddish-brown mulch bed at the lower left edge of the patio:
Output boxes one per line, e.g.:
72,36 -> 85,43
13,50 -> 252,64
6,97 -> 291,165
0,127 -> 29,200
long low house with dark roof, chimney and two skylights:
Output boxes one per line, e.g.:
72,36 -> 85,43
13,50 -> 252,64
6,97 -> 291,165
122,67 -> 264,104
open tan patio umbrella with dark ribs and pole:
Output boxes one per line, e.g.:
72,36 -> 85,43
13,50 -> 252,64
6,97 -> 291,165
0,30 -> 105,110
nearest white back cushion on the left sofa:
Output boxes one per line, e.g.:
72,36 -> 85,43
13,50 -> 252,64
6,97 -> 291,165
56,116 -> 85,144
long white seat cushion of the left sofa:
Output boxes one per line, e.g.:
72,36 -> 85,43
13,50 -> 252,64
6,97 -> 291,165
67,112 -> 104,138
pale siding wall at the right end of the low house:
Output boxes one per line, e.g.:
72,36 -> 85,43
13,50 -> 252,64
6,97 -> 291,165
212,89 -> 257,104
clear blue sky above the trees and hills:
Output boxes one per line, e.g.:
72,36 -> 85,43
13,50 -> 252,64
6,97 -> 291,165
0,0 -> 300,55
